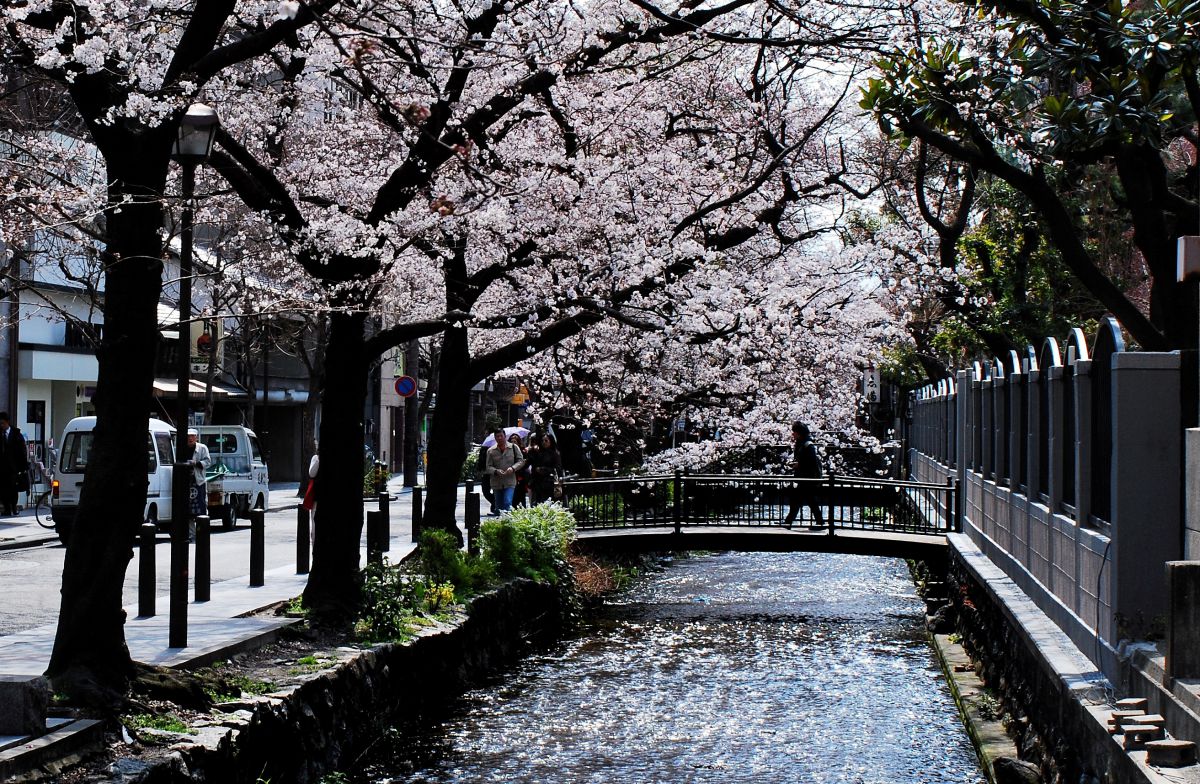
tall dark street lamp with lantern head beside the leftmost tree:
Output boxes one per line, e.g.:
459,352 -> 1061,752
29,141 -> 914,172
167,103 -> 220,648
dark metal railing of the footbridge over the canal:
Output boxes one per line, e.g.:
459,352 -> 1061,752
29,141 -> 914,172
564,473 -> 958,534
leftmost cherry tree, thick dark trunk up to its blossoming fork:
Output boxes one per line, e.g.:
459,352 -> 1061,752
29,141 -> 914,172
0,0 -> 335,705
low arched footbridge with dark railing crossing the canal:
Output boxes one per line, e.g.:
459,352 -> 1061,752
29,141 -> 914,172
563,472 -> 961,558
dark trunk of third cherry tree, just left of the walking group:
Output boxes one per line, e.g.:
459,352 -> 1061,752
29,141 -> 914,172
422,328 -> 475,540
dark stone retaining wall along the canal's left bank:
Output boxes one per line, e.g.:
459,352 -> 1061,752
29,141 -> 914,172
125,580 -> 562,784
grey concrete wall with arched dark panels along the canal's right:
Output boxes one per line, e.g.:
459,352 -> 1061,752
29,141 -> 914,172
910,321 -> 1185,678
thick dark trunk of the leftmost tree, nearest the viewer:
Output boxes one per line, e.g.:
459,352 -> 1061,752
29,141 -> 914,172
47,143 -> 169,707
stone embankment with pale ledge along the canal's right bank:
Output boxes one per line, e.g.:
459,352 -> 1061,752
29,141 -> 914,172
926,537 -> 1200,784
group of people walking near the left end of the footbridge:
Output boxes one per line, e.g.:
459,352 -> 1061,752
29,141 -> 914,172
476,429 -> 563,517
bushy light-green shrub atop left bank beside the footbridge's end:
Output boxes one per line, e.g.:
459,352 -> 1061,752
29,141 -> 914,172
480,503 -> 575,582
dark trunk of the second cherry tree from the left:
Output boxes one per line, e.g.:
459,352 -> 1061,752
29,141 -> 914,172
304,312 -> 367,620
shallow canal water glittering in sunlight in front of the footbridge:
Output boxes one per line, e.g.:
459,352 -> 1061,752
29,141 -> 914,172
352,553 -> 985,784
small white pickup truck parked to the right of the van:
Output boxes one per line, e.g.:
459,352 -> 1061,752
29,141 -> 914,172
196,425 -> 270,528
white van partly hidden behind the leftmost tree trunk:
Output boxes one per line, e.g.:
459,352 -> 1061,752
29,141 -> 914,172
50,417 -> 175,543
